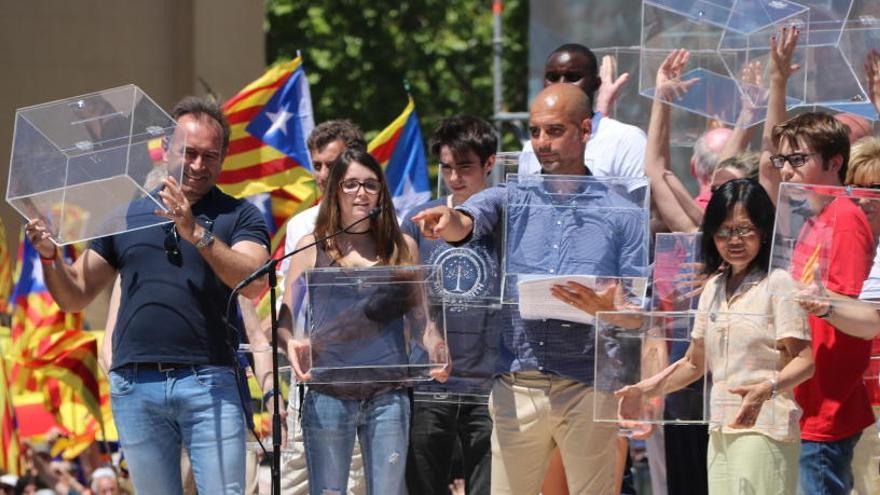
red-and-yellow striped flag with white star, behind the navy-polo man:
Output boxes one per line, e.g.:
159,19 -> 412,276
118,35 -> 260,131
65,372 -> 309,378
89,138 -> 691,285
217,57 -> 314,198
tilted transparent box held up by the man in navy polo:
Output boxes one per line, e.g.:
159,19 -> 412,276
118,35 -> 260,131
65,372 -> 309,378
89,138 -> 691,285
6,85 -> 186,244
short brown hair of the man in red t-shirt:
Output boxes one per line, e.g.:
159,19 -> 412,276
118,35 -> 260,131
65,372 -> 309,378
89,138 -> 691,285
772,112 -> 849,182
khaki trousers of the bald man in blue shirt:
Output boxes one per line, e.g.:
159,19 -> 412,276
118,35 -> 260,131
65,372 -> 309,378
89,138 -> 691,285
489,371 -> 617,495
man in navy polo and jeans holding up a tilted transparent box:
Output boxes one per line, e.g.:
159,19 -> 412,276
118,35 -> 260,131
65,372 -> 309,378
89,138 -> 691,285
26,97 -> 269,494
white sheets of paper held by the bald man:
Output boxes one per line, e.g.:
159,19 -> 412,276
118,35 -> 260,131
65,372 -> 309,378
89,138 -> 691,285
516,275 -> 596,325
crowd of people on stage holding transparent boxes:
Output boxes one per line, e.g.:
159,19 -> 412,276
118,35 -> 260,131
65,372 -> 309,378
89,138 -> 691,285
8,23 -> 880,495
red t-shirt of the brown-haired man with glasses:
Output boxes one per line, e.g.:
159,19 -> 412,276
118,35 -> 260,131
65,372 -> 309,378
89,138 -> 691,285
792,198 -> 875,442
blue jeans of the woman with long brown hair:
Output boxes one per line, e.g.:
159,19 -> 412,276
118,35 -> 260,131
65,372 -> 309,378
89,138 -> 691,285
302,390 -> 410,495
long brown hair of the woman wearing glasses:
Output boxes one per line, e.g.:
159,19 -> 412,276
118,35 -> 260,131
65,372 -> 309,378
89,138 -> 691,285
315,148 -> 410,265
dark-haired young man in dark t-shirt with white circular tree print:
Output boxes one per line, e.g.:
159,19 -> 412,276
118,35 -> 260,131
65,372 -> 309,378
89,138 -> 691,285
402,115 -> 500,495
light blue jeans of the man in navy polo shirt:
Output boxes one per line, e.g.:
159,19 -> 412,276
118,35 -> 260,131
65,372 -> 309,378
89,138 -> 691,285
110,365 -> 245,495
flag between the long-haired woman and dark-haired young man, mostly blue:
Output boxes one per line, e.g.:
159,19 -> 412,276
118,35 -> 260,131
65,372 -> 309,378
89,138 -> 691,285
367,97 -> 431,216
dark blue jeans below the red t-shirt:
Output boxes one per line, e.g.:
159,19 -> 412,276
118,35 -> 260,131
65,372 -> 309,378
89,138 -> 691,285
799,432 -> 862,495
